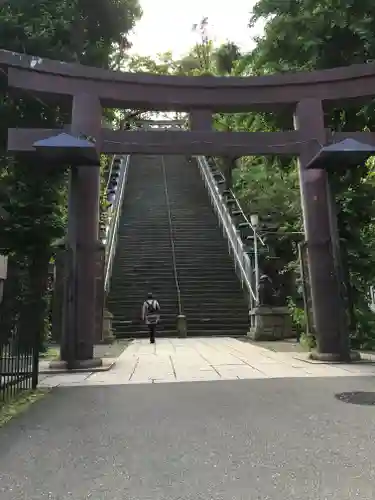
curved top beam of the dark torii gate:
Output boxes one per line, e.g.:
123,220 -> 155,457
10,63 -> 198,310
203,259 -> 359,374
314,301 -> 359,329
0,50 -> 375,112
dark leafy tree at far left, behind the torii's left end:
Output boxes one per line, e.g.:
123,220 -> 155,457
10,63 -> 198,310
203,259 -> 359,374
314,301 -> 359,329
0,0 -> 141,350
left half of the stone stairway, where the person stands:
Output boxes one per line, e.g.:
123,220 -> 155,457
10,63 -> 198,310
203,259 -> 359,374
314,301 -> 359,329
107,156 -> 178,337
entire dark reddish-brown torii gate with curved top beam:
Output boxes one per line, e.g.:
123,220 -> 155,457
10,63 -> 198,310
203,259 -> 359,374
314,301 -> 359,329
0,50 -> 375,364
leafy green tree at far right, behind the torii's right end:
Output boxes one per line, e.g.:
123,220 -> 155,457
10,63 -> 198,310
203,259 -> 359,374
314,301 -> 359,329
241,0 -> 375,347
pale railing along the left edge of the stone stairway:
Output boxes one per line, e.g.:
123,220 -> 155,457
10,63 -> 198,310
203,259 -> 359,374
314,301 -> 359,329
104,155 -> 130,293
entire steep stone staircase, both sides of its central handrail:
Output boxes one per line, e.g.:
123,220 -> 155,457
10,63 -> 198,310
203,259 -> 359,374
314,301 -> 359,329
108,156 -> 248,337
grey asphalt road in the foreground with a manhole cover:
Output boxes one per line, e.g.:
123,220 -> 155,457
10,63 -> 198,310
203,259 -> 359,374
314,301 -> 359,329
0,377 -> 375,500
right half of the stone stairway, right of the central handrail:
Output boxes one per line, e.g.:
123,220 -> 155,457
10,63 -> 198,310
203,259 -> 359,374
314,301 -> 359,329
163,156 -> 249,335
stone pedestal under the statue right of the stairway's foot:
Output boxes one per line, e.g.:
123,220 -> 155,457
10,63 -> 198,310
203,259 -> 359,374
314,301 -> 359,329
248,306 -> 293,340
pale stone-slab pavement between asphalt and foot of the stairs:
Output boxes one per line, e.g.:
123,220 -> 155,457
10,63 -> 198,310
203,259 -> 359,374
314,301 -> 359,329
40,337 -> 375,387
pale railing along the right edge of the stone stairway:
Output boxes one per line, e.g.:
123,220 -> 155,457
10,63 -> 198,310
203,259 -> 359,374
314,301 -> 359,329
196,156 -> 257,309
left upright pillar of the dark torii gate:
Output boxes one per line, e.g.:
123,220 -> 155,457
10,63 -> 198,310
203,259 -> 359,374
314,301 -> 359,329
62,94 -> 102,366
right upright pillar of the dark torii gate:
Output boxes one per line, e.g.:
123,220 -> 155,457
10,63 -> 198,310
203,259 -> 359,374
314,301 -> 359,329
295,99 -> 349,360
